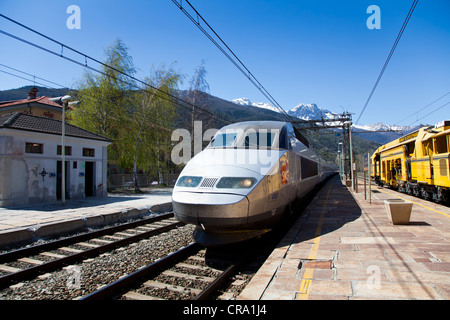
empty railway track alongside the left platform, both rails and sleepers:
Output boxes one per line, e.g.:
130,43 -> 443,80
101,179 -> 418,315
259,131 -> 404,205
0,213 -> 183,289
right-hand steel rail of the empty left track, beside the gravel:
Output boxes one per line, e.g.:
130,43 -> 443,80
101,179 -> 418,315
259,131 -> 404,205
0,222 -> 184,289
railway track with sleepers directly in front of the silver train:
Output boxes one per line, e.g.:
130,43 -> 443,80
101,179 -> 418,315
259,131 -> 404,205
82,243 -> 248,300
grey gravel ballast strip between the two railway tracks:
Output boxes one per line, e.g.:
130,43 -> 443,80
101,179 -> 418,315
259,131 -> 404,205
0,225 -> 194,300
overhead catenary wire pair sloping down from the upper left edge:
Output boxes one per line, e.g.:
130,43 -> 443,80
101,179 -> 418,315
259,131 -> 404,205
0,14 -> 232,124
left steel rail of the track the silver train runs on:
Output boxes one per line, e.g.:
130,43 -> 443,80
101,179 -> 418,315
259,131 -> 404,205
80,242 -> 201,300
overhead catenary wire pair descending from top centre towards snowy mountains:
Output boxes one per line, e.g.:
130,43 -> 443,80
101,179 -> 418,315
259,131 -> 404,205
172,0 -> 298,121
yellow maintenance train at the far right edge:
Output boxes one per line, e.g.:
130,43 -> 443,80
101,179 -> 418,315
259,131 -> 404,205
371,120 -> 450,204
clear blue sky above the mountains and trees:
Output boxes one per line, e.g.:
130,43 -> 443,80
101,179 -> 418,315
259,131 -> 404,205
0,0 -> 450,125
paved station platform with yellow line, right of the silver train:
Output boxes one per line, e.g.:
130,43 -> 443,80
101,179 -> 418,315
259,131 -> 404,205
238,176 -> 450,300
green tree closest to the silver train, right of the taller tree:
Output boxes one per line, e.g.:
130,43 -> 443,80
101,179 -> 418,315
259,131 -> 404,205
118,65 -> 181,191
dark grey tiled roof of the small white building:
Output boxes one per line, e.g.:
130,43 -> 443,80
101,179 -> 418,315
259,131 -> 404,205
0,112 -> 111,142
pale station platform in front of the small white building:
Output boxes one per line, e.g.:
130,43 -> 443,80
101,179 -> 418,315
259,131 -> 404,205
0,188 -> 172,250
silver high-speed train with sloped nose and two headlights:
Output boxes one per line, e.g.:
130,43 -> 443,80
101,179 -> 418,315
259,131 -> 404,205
172,121 -> 336,246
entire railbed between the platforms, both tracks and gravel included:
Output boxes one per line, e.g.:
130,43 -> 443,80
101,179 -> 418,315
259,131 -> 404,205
0,195 -> 310,300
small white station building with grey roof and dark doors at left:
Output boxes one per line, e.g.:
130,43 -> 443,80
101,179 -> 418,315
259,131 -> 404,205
0,112 -> 111,207
